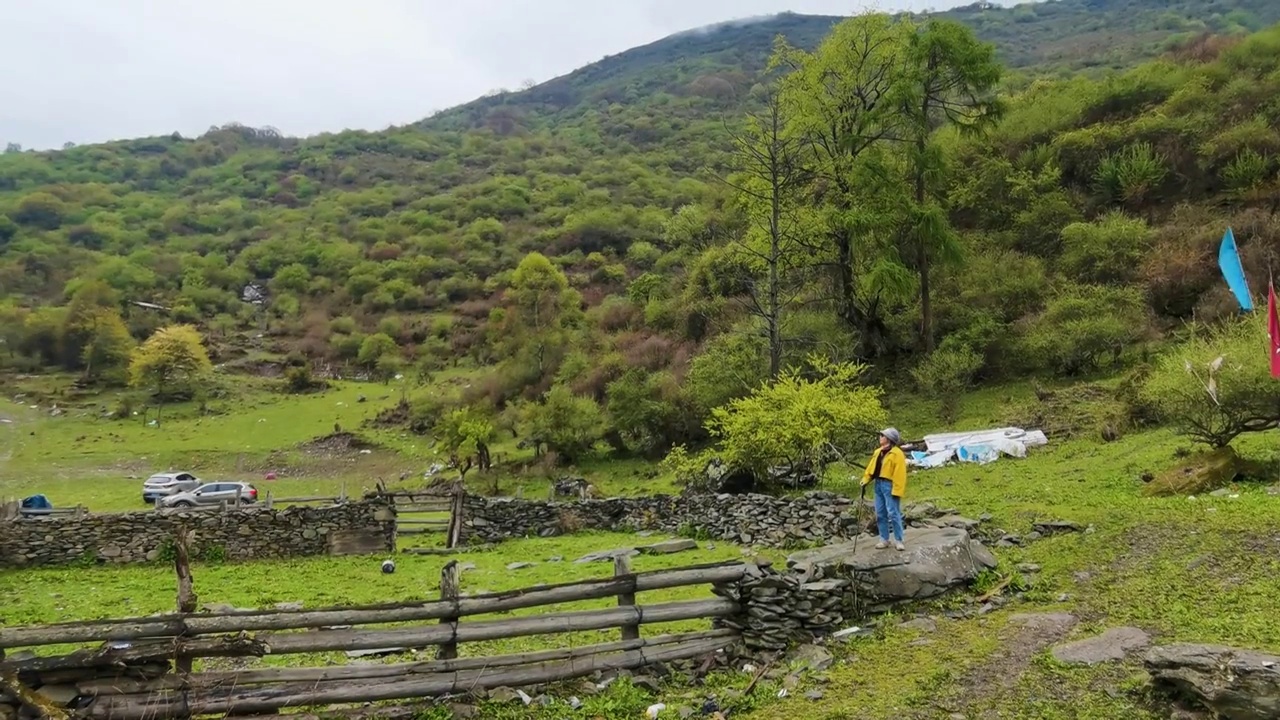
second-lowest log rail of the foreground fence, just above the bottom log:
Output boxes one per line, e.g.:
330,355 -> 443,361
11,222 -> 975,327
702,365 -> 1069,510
74,628 -> 739,696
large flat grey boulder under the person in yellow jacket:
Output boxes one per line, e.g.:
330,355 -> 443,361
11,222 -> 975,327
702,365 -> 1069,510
787,528 -> 996,611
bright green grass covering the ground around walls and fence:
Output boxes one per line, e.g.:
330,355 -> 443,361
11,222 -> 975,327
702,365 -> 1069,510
0,368 -> 1280,720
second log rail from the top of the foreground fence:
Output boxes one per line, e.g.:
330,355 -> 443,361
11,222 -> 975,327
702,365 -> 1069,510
4,598 -> 739,673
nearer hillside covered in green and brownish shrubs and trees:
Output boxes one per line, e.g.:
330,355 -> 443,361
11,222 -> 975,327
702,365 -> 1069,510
0,3 -> 1280,458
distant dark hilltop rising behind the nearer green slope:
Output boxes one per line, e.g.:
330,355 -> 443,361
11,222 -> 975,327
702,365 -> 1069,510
421,0 -> 1280,129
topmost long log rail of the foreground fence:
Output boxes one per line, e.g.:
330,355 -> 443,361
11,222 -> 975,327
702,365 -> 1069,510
0,562 -> 748,648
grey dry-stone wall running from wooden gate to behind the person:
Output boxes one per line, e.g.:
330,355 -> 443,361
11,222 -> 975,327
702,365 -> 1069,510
463,492 -> 977,547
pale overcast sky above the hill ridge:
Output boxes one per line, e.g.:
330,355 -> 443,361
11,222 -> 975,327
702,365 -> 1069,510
0,0 -> 972,149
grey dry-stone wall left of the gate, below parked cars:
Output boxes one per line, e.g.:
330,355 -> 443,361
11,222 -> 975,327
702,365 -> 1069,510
0,502 -> 396,568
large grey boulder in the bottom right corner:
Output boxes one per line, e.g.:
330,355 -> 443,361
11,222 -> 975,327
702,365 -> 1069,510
1146,644 -> 1280,720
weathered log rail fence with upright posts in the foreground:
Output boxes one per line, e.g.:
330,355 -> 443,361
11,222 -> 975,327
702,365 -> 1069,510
0,553 -> 746,720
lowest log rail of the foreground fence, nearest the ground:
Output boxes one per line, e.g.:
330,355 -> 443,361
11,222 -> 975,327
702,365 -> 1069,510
81,638 -> 732,720
